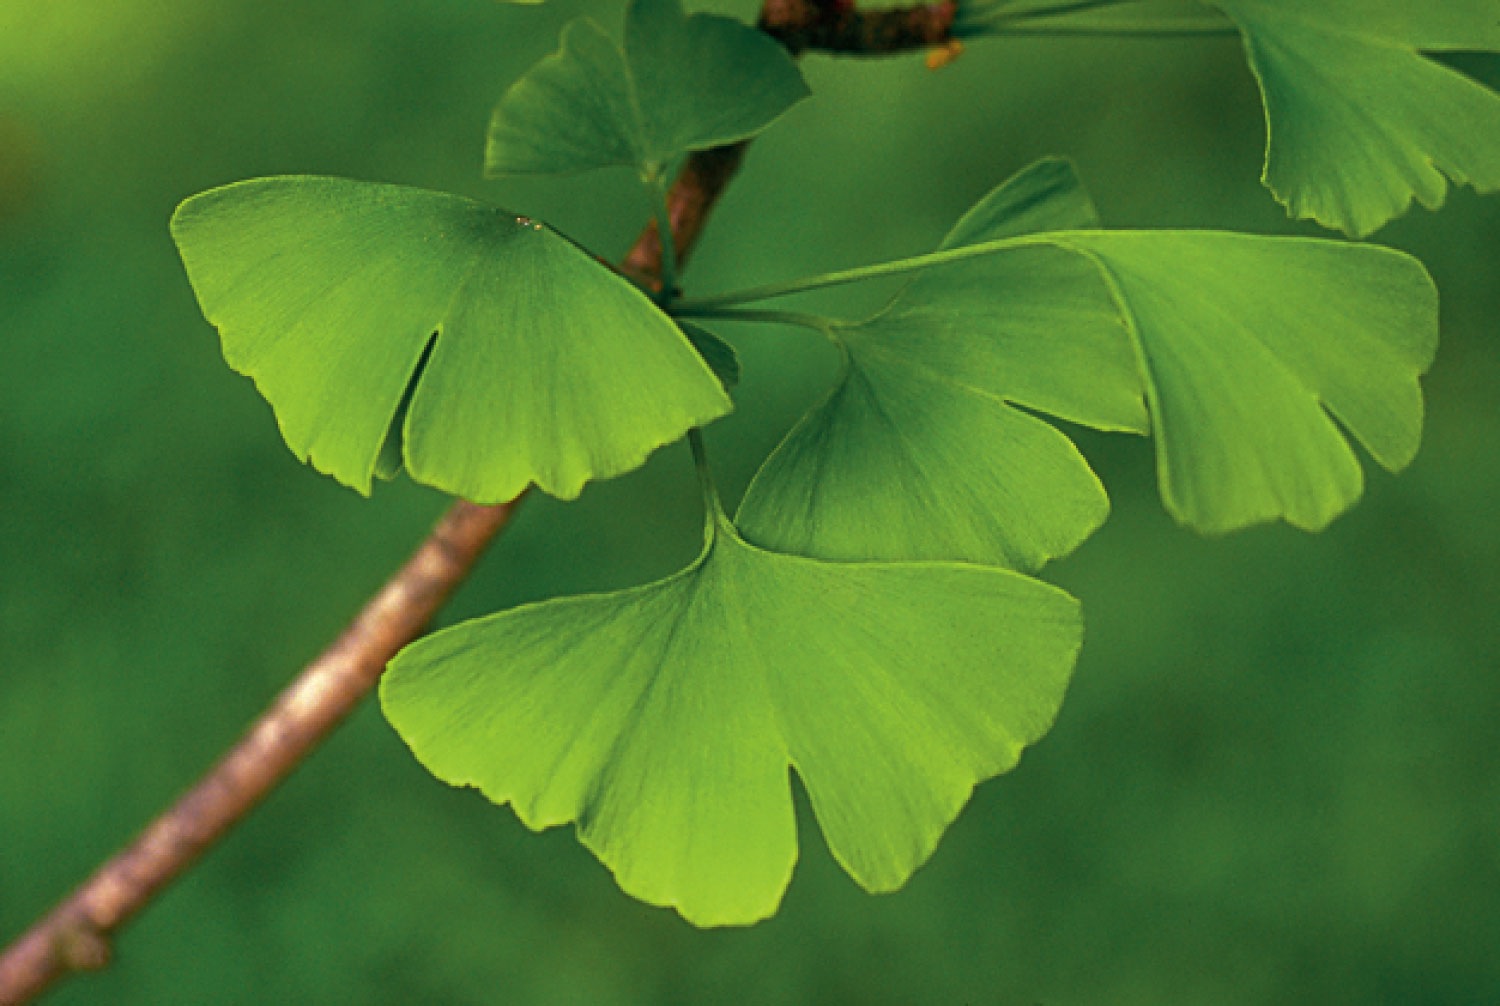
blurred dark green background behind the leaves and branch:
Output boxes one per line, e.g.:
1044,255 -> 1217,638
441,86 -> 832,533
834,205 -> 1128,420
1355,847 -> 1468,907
0,0 -> 1500,1006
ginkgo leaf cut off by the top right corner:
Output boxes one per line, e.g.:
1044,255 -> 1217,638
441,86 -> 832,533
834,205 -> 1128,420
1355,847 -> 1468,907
1206,0 -> 1500,237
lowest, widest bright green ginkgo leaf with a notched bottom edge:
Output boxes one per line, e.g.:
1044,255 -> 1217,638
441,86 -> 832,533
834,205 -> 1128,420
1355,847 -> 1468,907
381,504 -> 1080,925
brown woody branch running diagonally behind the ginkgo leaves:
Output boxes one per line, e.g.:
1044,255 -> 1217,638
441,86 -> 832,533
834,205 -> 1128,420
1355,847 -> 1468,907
0,0 -> 954,1006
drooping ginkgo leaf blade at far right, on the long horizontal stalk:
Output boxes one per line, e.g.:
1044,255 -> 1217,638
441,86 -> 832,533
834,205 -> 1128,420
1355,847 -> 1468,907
1058,231 -> 1437,532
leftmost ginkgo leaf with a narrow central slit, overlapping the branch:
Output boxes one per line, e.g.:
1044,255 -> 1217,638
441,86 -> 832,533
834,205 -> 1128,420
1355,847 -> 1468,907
173,177 -> 732,502
